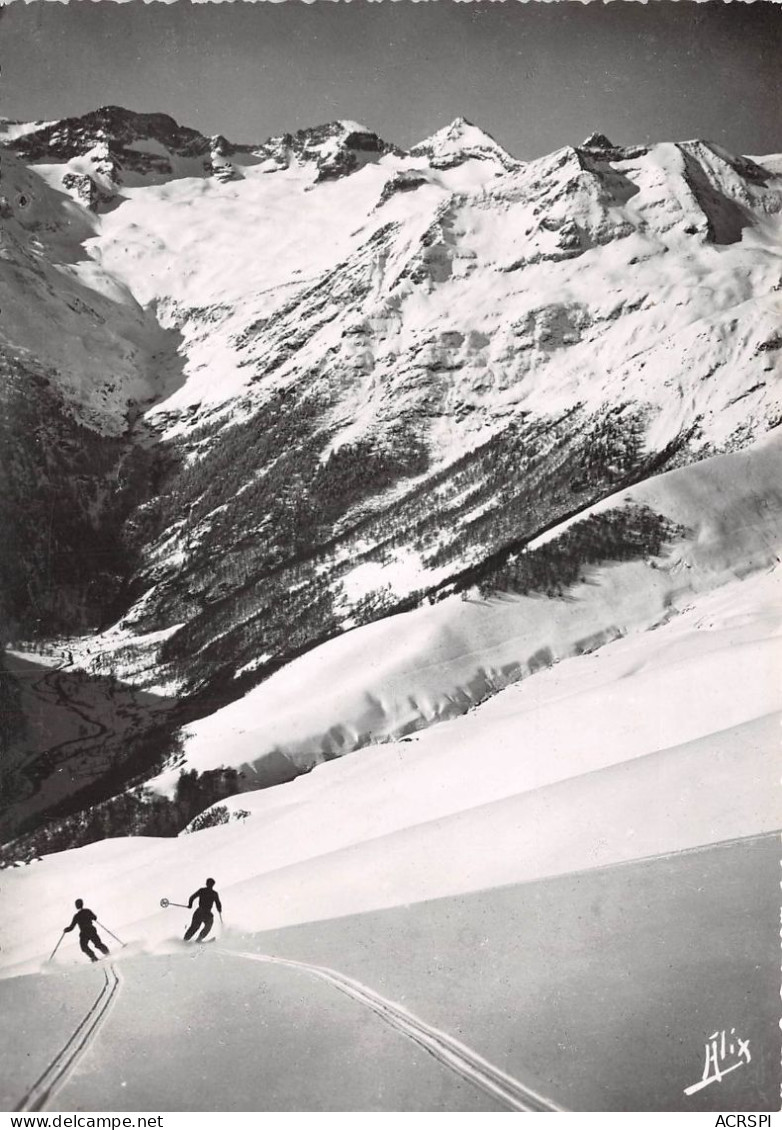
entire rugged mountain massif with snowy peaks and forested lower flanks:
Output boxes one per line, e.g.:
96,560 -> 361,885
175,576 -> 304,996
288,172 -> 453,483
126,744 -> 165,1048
0,107 -> 782,849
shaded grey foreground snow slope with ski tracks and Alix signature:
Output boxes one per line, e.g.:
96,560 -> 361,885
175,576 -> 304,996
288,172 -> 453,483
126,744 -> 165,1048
0,836 -> 779,1112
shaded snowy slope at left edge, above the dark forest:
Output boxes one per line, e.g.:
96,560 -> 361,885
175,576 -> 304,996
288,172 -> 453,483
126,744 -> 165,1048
0,151 -> 181,435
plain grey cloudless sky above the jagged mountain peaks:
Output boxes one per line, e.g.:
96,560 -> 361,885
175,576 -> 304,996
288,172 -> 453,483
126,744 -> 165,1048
0,0 -> 782,159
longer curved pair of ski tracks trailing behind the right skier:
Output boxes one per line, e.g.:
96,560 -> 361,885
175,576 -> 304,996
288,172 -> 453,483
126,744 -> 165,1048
223,949 -> 565,1112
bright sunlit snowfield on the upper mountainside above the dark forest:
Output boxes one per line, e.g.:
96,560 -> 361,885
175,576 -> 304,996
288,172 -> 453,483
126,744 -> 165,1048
80,129 -> 780,449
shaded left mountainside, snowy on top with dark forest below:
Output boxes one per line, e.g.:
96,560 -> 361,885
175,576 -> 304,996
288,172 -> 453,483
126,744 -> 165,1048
0,142 -> 181,640
